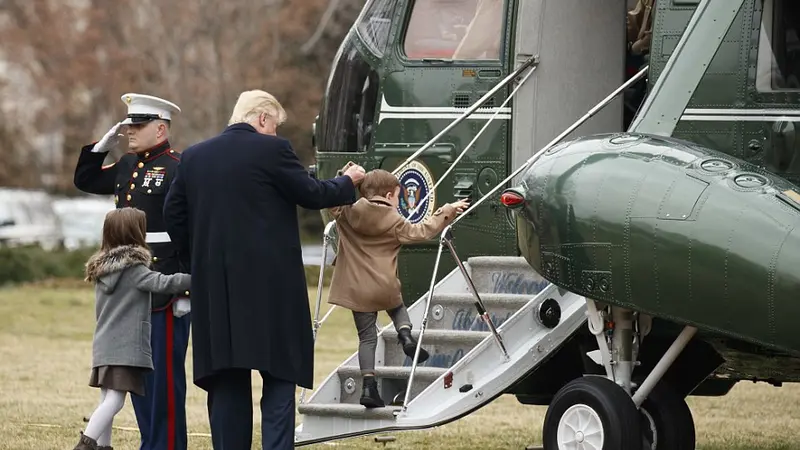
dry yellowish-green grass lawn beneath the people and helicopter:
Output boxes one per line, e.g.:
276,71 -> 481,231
0,282 -> 800,450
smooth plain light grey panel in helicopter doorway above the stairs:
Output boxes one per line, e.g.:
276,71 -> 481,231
512,0 -> 628,174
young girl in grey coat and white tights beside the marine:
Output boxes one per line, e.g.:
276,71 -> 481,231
73,208 -> 191,450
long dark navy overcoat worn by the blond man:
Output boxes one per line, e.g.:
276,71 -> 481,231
164,124 -> 356,389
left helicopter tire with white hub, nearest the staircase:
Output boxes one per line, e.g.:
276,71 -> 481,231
542,376 -> 642,450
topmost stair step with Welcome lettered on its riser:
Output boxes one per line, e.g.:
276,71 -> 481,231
462,256 -> 550,296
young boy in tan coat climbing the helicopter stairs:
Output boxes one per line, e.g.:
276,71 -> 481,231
328,169 -> 469,408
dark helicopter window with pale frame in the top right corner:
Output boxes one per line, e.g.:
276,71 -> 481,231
756,0 -> 800,92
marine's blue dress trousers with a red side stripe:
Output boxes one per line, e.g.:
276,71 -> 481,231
131,306 -> 191,450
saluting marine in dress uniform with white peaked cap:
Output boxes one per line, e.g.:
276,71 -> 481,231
74,94 -> 190,450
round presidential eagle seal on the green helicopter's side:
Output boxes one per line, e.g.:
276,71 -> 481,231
397,161 -> 436,223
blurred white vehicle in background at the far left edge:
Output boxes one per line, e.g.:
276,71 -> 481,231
0,188 -> 64,250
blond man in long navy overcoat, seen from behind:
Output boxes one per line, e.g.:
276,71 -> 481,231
164,90 -> 364,450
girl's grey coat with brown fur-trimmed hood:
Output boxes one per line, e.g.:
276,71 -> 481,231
86,246 -> 191,369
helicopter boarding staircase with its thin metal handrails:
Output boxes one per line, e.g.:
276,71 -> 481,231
295,51 -> 647,446
